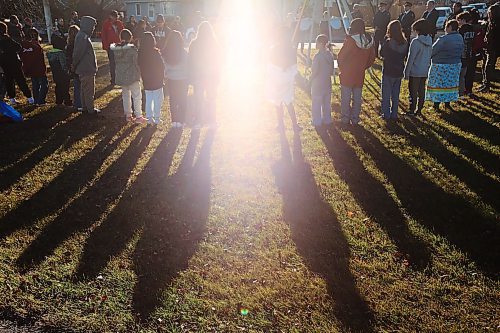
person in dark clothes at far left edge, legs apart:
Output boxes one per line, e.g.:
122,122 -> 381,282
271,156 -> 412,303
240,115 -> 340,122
0,21 -> 35,105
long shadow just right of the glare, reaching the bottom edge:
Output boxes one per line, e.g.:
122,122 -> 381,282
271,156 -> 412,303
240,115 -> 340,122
273,132 -> 373,332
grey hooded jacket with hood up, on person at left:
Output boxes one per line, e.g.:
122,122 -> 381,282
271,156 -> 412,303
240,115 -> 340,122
73,16 -> 97,76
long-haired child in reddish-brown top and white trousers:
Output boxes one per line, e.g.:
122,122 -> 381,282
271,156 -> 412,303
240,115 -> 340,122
138,32 -> 165,125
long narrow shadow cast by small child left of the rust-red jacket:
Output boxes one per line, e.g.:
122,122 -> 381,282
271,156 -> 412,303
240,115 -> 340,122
318,128 -> 430,269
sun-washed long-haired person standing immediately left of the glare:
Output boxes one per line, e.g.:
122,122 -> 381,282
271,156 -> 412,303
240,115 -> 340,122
188,21 -> 220,128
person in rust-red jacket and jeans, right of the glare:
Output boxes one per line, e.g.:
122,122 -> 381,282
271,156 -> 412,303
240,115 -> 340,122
337,19 -> 375,125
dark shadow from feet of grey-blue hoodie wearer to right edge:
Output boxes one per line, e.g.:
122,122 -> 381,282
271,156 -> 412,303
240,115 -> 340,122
398,116 -> 500,212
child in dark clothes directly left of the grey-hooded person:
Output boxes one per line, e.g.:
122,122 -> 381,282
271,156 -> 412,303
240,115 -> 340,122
47,34 -> 72,106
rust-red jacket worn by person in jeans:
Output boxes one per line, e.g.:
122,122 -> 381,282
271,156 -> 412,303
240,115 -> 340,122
337,35 -> 375,88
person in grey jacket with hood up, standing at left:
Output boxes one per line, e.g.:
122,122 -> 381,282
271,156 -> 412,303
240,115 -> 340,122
72,16 -> 100,113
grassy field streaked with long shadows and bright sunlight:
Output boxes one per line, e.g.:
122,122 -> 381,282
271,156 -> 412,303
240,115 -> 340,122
0,44 -> 500,332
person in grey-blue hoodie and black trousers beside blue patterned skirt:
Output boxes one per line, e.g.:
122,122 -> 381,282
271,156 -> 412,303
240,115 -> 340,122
404,19 -> 432,116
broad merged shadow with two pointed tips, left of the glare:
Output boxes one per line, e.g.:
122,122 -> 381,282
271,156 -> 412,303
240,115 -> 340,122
75,130 -> 214,320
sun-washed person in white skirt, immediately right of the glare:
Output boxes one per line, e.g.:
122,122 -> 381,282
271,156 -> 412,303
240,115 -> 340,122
267,28 -> 302,132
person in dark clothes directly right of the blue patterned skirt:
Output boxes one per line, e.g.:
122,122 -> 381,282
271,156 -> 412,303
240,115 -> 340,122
457,12 -> 476,96
